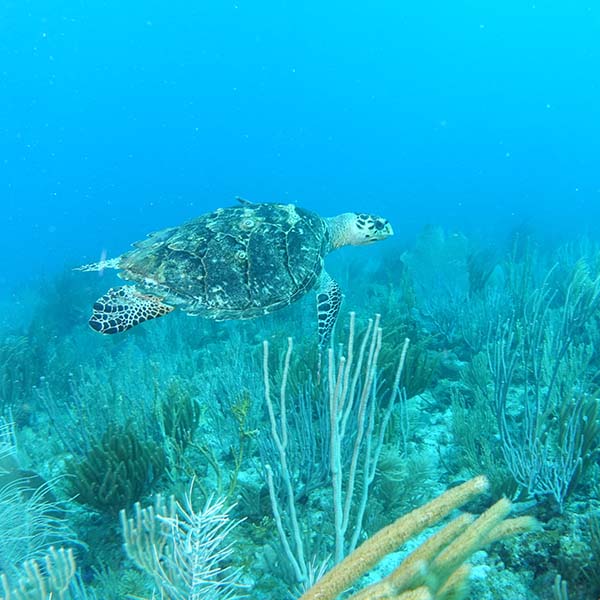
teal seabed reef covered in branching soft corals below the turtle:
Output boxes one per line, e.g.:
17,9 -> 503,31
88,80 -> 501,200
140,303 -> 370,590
0,227 -> 600,600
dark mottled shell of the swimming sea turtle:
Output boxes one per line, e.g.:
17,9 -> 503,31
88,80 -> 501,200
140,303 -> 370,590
115,202 -> 330,319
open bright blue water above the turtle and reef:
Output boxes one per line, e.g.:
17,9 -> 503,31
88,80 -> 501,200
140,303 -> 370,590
0,0 -> 600,281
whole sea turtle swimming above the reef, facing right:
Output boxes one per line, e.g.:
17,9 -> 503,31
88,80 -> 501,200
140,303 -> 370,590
79,199 -> 393,347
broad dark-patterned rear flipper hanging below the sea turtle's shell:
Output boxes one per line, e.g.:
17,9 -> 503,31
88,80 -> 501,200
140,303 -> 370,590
89,285 -> 175,333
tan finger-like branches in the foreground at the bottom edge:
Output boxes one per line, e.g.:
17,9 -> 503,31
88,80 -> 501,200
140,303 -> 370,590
300,477 -> 536,600
